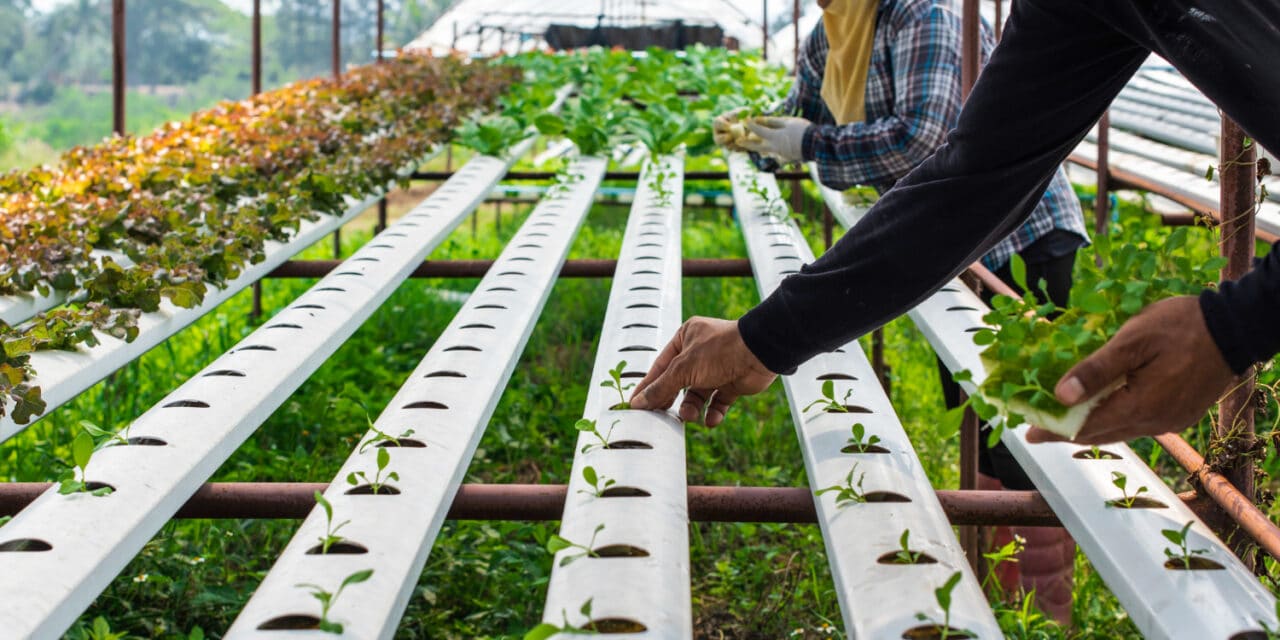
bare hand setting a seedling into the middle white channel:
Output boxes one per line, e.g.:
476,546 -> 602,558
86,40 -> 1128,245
631,316 -> 777,426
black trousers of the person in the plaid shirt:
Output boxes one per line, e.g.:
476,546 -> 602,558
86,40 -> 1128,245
938,251 -> 1075,492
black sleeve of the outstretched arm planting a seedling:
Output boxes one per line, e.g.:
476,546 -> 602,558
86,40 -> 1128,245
739,0 -> 1147,372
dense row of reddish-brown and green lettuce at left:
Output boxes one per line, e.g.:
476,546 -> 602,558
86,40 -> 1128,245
0,55 -> 517,424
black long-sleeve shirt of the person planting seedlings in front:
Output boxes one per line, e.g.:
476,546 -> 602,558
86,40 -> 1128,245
739,0 -> 1280,372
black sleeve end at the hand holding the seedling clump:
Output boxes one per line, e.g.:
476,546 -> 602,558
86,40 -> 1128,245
1199,242 -> 1280,374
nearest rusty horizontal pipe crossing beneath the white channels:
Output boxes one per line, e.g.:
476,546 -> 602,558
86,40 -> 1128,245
0,483 -> 1059,526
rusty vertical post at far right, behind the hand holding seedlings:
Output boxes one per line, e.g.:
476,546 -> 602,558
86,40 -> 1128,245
1210,115 -> 1257,567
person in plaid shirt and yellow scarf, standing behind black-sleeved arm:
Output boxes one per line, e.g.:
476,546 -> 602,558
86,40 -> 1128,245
717,0 -> 1088,623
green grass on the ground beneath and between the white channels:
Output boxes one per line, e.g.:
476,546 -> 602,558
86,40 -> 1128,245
0,156 -> 1280,640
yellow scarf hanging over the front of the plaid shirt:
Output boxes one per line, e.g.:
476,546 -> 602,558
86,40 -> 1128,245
822,0 -> 879,124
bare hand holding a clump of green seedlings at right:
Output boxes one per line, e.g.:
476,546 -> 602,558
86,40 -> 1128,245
1027,296 -> 1236,444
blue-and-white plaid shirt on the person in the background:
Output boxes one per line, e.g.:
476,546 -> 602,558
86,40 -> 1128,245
776,0 -> 1088,270
